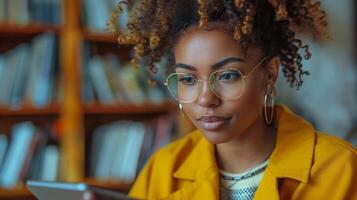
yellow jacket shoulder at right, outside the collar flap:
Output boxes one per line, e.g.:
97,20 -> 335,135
294,132 -> 357,199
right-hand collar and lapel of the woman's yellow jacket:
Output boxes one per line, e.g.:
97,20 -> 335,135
254,105 -> 316,200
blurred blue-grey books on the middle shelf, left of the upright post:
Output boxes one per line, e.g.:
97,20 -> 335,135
0,33 -> 58,108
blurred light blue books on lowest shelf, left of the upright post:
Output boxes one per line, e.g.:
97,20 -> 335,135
0,121 -> 60,188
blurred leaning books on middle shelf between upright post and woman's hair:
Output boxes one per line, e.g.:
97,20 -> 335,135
82,42 -> 169,105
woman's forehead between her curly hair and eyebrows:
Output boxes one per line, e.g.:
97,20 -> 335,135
174,29 -> 263,74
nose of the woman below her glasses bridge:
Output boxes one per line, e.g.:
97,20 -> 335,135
197,81 -> 221,107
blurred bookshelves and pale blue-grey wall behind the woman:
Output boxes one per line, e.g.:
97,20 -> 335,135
0,0 -> 357,199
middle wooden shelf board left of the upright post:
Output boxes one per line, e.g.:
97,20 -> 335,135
0,105 -> 59,117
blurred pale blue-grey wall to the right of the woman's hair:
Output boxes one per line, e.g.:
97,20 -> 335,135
277,0 -> 357,142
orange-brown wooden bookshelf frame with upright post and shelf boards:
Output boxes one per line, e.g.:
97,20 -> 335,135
0,0 -> 188,199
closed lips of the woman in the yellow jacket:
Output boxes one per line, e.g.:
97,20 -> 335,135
197,115 -> 231,131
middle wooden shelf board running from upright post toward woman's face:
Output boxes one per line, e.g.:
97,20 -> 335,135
84,102 -> 177,115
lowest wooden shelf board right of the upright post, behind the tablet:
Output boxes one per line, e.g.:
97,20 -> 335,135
84,178 -> 132,192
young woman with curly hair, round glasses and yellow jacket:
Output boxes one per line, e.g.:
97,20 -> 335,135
111,0 -> 357,200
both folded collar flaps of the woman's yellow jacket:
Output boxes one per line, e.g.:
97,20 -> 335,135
174,105 -> 315,182
